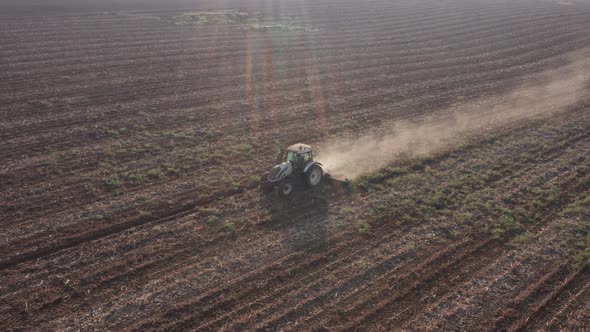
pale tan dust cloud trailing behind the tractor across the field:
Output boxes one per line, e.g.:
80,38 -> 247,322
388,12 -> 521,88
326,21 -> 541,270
318,49 -> 590,179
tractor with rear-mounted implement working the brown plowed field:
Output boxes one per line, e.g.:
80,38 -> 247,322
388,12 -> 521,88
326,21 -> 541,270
260,143 -> 350,197
